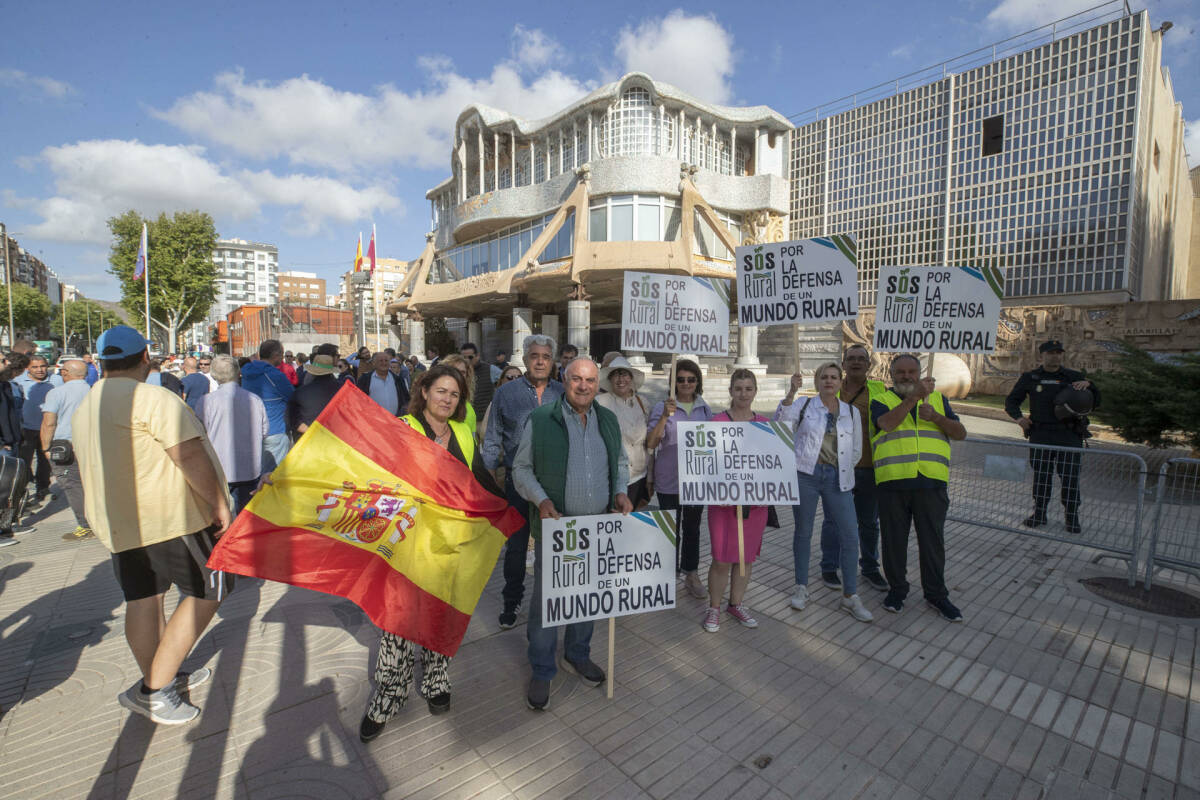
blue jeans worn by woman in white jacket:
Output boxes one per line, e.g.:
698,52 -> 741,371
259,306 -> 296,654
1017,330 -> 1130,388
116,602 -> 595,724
792,464 -> 858,595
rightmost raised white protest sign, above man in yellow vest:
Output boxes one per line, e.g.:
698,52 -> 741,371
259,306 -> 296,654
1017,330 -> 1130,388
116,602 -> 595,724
874,266 -> 1004,353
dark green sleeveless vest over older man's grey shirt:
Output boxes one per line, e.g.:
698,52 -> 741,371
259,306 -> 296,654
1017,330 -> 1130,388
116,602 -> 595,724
529,399 -> 629,539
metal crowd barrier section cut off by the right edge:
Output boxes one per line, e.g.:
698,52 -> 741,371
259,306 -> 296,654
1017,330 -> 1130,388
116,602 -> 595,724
1145,458 -> 1200,590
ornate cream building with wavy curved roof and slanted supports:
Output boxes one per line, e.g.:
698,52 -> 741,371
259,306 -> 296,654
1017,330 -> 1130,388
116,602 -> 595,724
389,72 -> 792,363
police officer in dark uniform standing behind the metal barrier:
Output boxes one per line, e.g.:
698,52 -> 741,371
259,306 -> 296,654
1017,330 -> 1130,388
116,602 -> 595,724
1004,339 -> 1100,534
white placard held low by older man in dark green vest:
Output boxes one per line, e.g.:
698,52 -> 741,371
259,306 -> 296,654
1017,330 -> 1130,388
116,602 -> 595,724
539,511 -> 676,627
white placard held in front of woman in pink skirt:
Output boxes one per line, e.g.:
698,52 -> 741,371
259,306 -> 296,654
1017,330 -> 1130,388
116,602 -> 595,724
676,422 -> 800,506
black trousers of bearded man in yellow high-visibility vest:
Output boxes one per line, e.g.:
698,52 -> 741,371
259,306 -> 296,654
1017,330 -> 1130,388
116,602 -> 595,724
877,483 -> 950,600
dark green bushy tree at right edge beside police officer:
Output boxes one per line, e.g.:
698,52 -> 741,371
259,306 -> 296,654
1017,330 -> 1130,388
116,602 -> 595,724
1090,342 -> 1200,450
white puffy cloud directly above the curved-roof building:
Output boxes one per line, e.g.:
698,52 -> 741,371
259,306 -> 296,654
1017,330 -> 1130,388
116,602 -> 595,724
617,8 -> 737,103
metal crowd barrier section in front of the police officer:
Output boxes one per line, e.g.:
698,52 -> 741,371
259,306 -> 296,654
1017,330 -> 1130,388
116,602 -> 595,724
947,438 -> 1147,587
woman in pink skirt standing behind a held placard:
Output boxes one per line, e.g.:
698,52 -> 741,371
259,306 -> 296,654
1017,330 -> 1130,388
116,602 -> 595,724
703,369 -> 767,633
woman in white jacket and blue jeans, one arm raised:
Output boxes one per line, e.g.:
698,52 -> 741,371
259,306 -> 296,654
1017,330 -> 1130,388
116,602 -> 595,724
775,363 -> 874,622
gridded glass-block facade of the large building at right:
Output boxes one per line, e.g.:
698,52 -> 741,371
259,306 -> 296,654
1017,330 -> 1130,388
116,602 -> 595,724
791,12 -> 1148,306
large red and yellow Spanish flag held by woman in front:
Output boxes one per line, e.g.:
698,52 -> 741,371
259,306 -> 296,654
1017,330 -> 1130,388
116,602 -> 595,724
209,385 -> 522,656
